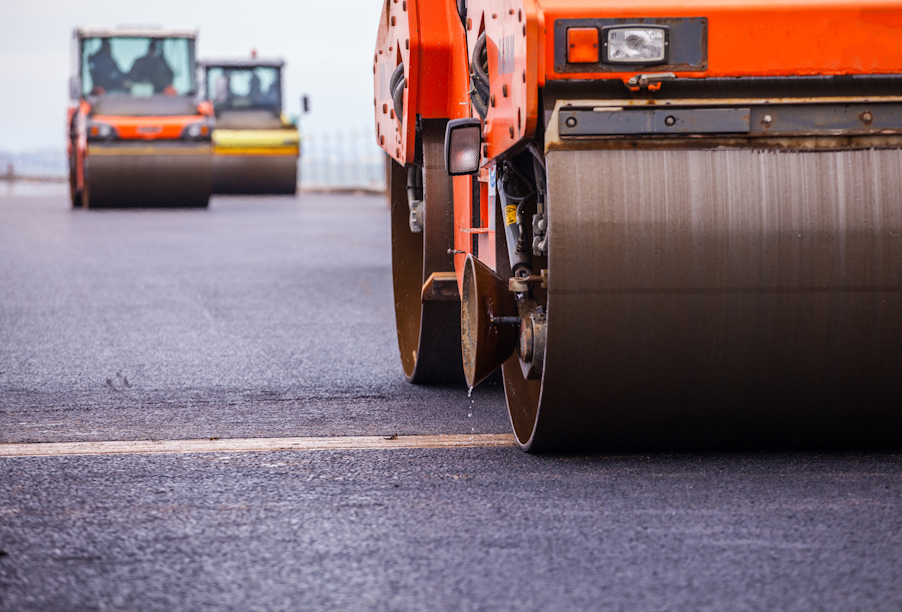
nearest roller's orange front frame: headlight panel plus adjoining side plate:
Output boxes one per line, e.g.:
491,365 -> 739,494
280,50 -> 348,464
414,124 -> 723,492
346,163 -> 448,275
467,0 -> 902,159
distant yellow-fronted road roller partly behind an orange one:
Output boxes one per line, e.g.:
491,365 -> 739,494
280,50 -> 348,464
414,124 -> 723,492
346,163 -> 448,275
202,57 -> 307,195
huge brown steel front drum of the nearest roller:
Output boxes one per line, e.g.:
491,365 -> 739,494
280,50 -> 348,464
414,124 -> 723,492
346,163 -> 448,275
504,149 -> 902,451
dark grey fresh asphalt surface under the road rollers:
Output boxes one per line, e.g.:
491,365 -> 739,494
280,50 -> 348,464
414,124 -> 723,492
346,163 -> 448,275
0,184 -> 902,611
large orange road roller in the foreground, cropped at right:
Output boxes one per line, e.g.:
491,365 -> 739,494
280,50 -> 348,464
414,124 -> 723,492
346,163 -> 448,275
373,0 -> 902,451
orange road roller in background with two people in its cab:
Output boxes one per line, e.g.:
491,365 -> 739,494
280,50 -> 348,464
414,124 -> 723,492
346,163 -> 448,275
68,28 -> 213,208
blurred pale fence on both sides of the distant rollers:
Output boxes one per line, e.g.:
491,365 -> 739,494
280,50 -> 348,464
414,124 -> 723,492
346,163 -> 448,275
0,130 -> 385,190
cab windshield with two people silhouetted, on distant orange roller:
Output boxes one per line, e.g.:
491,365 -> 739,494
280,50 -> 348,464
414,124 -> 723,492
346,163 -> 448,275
81,38 -> 197,98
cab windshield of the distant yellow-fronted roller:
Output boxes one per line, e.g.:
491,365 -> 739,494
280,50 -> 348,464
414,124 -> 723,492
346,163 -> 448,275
207,66 -> 282,113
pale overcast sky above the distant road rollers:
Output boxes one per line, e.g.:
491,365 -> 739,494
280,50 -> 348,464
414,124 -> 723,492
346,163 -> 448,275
0,0 -> 382,151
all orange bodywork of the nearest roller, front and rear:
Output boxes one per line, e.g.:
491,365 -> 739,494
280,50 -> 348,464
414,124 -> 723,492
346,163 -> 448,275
373,0 -> 902,284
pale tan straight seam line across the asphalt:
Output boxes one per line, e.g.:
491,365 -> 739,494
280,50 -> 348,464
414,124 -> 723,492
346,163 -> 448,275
0,434 -> 516,458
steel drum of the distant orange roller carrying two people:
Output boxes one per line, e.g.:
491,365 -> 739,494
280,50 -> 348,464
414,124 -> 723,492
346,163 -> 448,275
83,147 -> 213,208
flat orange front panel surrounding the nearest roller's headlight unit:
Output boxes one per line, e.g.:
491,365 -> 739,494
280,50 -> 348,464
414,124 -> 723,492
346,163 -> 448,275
542,0 -> 902,80
